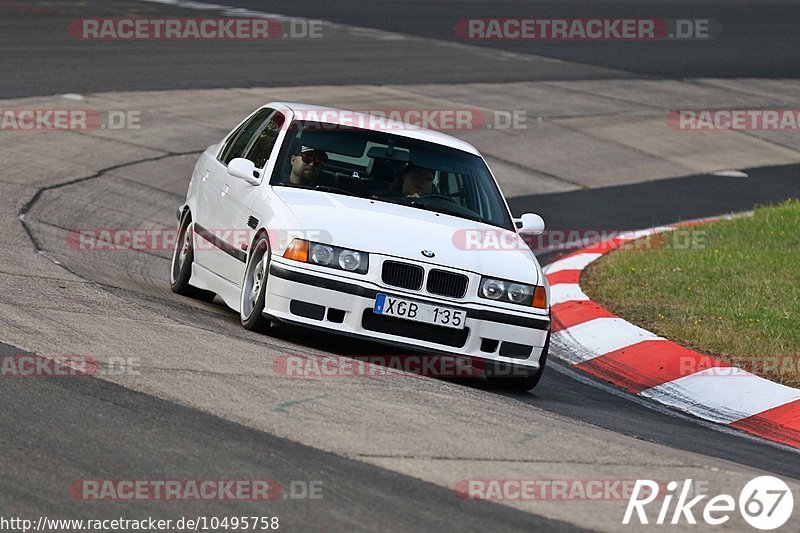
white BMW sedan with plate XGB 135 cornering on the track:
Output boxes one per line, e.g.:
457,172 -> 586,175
170,102 -> 550,390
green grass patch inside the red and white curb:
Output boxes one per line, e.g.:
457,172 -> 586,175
581,200 -> 800,387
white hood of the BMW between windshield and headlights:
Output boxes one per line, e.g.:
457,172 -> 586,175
273,186 -> 539,284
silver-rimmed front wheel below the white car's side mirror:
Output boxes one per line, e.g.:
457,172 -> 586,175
239,234 -> 271,333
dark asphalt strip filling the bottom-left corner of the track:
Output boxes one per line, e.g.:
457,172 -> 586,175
0,338 -> 571,531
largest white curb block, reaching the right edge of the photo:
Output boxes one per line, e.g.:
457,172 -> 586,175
640,368 -> 800,424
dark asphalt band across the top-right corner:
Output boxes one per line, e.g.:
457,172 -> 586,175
222,0 -> 800,79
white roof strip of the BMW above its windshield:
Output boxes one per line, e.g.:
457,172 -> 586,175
272,102 -> 480,156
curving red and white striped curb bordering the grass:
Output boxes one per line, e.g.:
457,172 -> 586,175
544,221 -> 800,448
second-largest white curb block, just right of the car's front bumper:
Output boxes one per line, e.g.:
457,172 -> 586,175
553,318 -> 661,364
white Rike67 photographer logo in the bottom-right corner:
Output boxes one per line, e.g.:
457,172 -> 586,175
622,476 -> 796,531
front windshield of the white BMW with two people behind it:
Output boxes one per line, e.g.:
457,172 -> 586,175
270,121 -> 514,230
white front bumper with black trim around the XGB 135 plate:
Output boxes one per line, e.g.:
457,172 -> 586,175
264,257 -> 550,369
